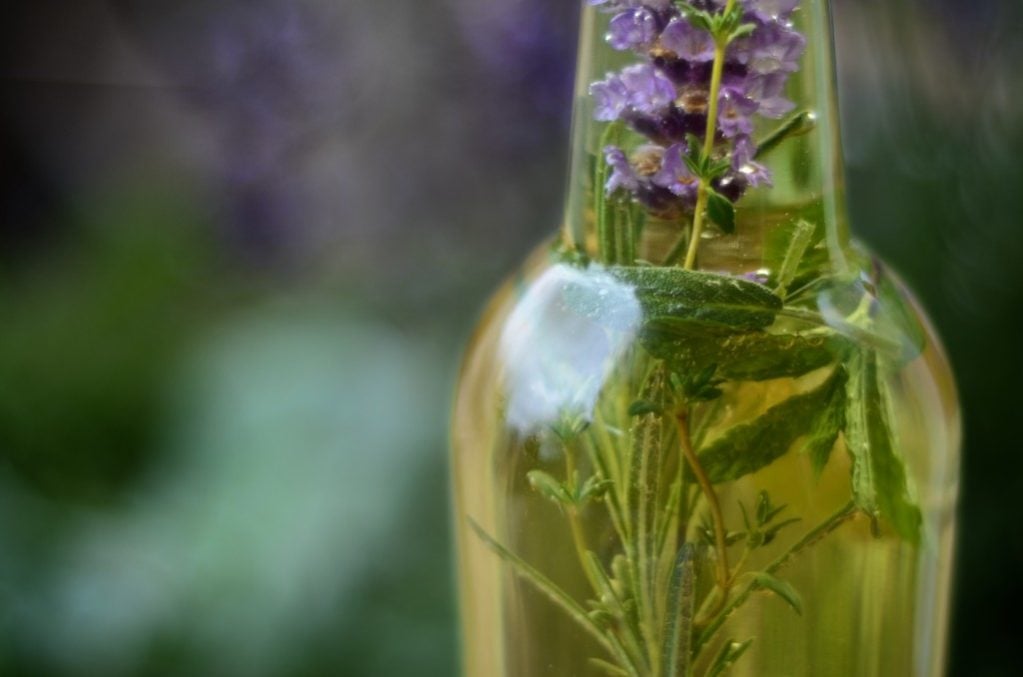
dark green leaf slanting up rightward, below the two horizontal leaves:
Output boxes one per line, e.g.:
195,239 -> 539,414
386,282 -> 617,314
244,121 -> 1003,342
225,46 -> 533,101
700,369 -> 846,484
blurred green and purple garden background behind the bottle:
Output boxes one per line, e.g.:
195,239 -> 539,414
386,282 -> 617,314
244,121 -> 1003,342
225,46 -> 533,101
0,0 -> 1023,677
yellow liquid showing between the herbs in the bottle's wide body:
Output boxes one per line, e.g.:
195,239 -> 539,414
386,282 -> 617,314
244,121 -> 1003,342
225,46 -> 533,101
453,248 -> 959,677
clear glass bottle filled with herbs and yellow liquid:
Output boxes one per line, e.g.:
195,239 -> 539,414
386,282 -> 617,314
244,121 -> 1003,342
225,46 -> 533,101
452,0 -> 960,677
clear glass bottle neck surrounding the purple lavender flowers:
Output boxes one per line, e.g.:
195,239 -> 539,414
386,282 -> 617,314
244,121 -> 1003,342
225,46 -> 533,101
564,0 -> 849,274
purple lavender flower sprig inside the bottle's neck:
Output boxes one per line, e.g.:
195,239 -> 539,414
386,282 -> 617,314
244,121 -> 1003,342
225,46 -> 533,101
589,0 -> 806,268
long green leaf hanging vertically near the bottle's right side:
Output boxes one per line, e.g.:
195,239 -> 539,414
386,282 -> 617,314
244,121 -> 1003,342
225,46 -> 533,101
845,350 -> 923,543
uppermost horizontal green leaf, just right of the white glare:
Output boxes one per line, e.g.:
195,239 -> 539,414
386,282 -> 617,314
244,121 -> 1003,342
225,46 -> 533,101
609,266 -> 782,331
